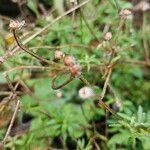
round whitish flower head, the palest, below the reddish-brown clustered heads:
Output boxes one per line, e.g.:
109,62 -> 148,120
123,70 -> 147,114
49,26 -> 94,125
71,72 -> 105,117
79,86 -> 94,99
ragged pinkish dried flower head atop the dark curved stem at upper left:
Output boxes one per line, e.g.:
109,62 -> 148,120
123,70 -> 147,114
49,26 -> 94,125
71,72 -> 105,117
9,20 -> 25,30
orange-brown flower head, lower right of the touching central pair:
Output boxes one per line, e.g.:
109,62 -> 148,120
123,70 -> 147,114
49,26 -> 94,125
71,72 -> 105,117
70,64 -> 82,77
